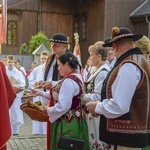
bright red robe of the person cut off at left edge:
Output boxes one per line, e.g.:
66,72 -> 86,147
0,61 -> 16,150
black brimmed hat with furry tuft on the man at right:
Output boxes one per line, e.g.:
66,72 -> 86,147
103,27 -> 143,47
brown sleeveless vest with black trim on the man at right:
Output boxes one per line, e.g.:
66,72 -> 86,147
100,48 -> 150,147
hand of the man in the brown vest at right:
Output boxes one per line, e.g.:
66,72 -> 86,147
86,101 -> 99,117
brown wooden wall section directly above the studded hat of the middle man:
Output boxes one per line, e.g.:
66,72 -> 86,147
40,0 -> 73,38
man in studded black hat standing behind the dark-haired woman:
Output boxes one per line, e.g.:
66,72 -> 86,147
35,33 -> 70,89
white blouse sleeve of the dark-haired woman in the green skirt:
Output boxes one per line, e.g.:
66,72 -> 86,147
42,74 -> 82,123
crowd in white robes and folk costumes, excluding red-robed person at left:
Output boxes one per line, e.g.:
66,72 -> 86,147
0,27 -> 150,150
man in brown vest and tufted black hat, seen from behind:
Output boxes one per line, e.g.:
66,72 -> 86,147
87,27 -> 150,150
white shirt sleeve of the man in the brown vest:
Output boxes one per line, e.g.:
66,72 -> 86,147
95,63 -> 141,118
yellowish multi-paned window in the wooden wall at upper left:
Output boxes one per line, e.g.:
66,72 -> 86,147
7,21 -> 17,45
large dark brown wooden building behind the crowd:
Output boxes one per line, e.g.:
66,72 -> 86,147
1,0 -> 149,64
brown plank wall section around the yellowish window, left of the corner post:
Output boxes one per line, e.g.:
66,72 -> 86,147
1,11 -> 37,54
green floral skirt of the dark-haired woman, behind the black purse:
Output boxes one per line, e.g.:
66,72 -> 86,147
50,117 -> 89,150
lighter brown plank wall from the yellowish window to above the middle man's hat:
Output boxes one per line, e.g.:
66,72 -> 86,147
1,0 -> 73,54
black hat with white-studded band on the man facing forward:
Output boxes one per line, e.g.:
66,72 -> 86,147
50,33 -> 71,44
